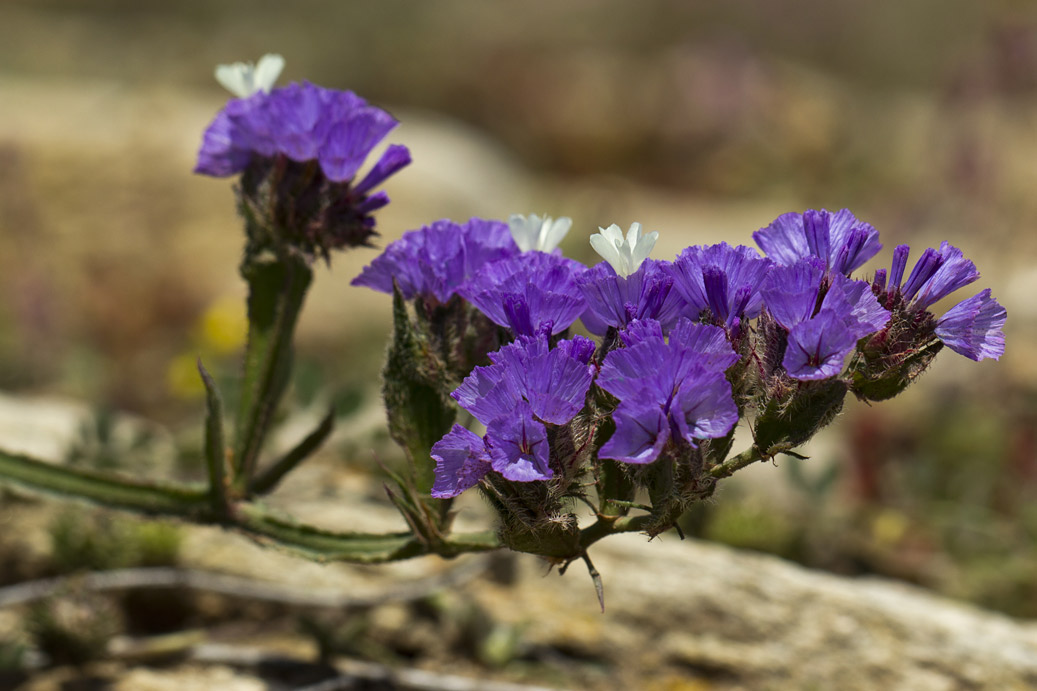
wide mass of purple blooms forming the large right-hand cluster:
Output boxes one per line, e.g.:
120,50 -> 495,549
354,204 -> 1005,497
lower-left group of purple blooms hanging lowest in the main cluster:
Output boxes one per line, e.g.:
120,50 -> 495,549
432,331 -> 594,497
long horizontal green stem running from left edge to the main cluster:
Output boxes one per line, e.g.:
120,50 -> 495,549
0,451 -> 501,563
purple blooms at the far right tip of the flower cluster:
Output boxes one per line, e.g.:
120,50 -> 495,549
872,242 -> 1007,360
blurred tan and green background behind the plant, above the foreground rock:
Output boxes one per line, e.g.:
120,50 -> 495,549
0,0 -> 1037,616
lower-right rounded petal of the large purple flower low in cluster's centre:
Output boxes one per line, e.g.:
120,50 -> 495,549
670,369 -> 738,446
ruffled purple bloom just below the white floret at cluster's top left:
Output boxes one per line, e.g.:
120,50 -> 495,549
458,252 -> 586,336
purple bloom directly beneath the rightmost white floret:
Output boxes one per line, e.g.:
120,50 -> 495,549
577,259 -> 684,335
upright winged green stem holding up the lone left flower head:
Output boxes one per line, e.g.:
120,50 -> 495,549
233,257 -> 313,494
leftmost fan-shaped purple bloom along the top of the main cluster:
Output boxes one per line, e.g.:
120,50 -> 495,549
353,218 -> 519,302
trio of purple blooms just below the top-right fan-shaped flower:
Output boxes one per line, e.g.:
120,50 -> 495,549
761,257 -> 890,381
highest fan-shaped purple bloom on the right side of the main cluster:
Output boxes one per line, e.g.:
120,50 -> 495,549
753,209 -> 882,275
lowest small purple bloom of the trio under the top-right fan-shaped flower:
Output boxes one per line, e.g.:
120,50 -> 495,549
782,309 -> 858,381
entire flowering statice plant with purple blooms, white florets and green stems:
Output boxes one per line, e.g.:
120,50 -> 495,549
0,56 -> 1006,593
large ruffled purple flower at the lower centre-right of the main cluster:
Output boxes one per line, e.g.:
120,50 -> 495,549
597,317 -> 738,464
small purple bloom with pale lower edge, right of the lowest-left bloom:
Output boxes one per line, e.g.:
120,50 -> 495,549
486,404 -> 555,482
